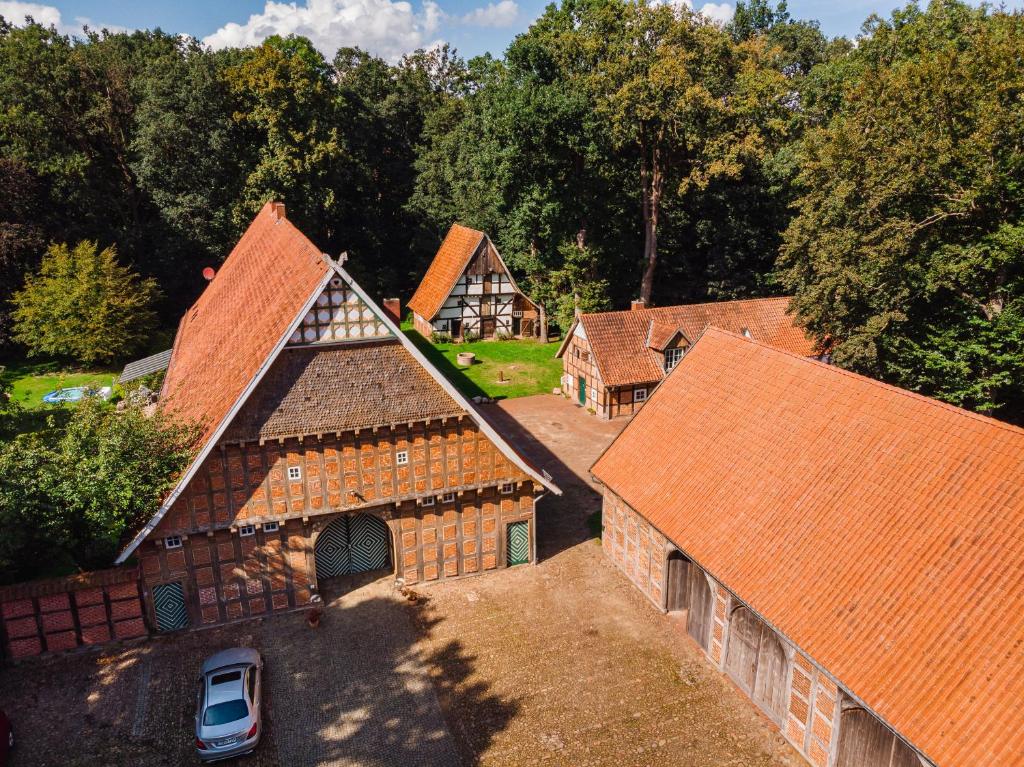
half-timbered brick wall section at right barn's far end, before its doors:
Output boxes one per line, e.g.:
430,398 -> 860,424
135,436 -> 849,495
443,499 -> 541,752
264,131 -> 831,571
601,487 -> 669,609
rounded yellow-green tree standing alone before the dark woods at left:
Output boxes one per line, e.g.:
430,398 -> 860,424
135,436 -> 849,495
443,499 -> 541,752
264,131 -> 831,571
12,242 -> 160,365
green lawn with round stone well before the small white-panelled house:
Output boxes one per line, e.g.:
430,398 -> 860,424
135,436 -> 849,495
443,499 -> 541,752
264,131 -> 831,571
402,324 -> 562,399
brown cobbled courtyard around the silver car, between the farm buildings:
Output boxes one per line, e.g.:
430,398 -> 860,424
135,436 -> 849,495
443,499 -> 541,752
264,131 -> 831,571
0,395 -> 806,767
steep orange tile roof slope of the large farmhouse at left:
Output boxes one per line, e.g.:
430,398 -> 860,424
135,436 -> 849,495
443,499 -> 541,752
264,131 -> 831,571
161,203 -> 331,443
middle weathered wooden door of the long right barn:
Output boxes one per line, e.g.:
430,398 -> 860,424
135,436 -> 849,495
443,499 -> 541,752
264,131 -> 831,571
725,605 -> 786,722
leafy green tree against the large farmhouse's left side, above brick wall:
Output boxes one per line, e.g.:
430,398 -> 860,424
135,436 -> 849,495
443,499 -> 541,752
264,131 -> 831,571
0,399 -> 197,581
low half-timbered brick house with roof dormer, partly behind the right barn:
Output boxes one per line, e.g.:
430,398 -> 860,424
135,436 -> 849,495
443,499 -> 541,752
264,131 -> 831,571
557,298 -> 816,418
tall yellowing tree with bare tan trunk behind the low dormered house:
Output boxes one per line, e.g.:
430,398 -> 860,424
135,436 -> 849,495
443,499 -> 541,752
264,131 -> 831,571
592,2 -> 786,302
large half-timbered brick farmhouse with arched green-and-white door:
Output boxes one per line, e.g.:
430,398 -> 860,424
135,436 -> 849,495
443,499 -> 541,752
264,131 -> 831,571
119,204 -> 558,630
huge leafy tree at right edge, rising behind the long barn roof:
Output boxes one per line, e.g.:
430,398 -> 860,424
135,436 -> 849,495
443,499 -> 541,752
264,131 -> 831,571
779,0 -> 1024,422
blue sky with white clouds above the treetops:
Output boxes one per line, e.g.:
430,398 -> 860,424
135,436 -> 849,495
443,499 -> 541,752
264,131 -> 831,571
0,0 -> 1024,61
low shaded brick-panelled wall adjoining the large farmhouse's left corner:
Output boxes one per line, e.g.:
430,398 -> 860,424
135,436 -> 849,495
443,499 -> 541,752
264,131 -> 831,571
0,567 -> 148,659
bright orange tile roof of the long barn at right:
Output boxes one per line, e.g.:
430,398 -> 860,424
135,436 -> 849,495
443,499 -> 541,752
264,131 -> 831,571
592,328 -> 1024,766
